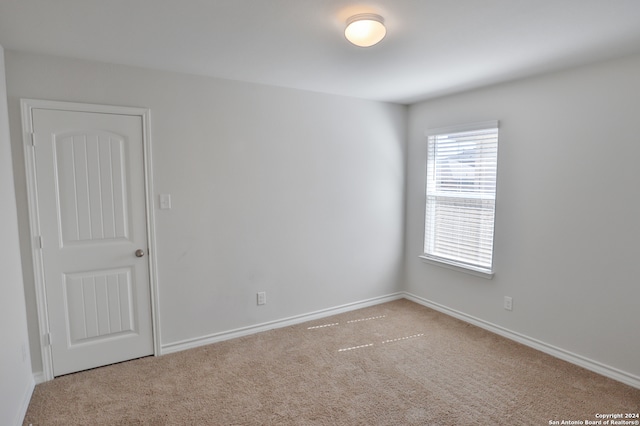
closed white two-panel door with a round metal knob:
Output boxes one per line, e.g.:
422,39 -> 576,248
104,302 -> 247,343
32,108 -> 153,376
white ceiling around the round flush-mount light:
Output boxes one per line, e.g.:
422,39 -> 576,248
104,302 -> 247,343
0,0 -> 640,103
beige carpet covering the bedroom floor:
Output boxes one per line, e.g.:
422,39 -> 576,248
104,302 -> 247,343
24,300 -> 640,426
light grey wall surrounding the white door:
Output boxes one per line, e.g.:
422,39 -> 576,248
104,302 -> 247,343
7,51 -> 406,371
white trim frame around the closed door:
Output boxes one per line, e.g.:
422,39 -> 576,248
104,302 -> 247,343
20,99 -> 160,382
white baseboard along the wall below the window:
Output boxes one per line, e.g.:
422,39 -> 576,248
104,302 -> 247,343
403,292 -> 640,389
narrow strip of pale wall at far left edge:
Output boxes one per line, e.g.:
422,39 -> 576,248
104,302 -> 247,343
0,46 -> 34,425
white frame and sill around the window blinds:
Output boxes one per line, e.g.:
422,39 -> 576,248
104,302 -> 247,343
419,120 -> 500,279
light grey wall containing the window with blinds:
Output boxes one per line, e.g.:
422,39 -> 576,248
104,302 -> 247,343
405,52 -> 640,383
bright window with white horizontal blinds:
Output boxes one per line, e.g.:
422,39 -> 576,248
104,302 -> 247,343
421,121 -> 498,277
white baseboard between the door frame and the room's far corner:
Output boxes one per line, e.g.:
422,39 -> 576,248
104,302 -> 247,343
160,293 -> 405,355
